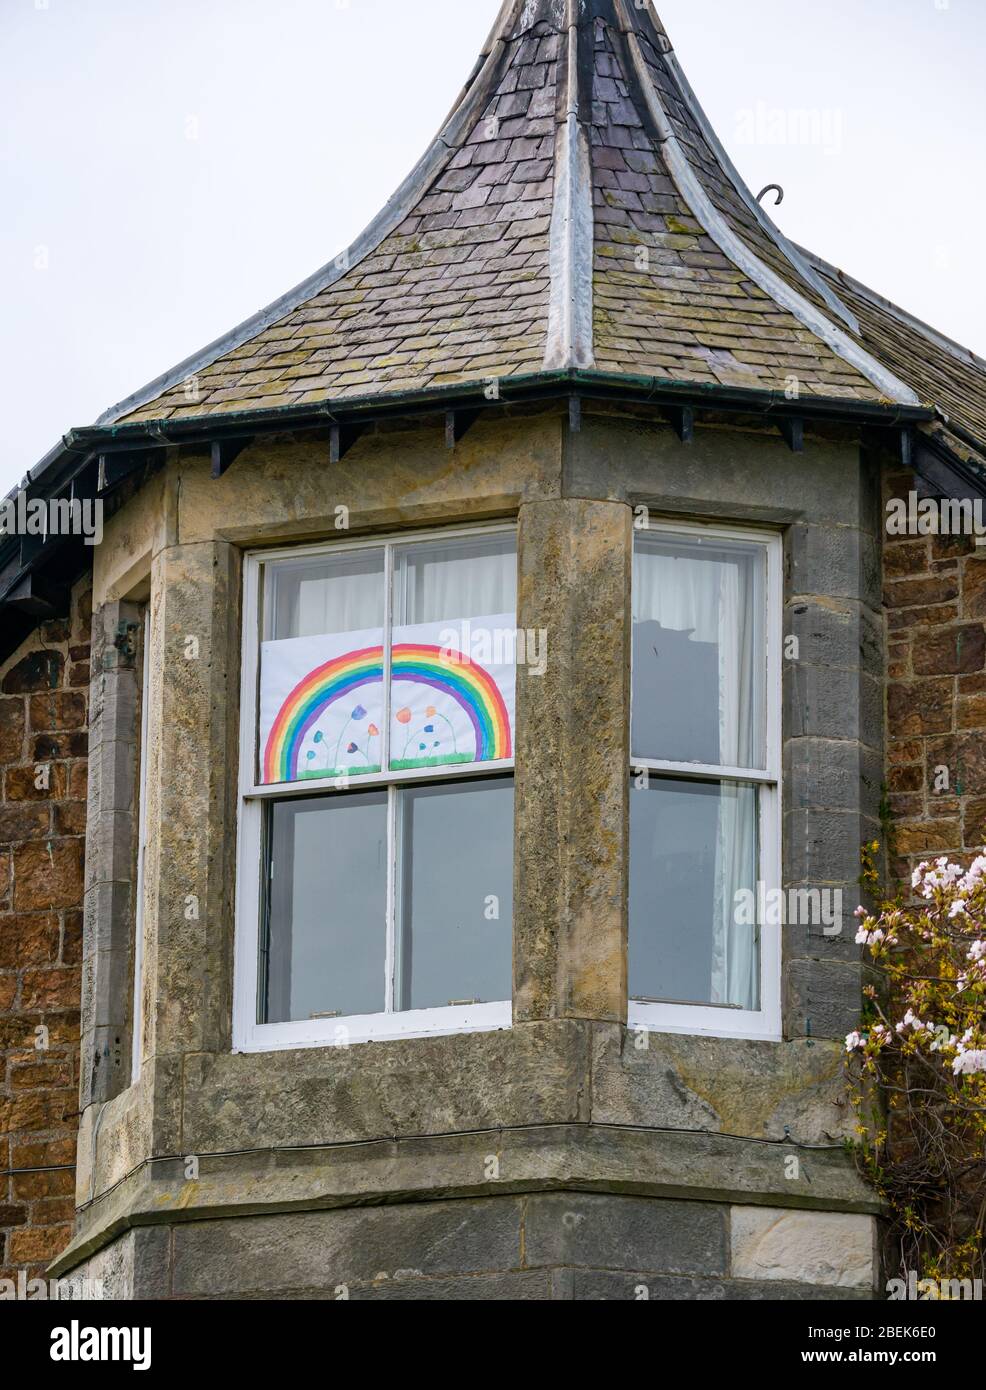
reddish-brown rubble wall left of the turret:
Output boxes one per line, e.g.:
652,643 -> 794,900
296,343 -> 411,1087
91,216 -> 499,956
0,582 -> 92,1277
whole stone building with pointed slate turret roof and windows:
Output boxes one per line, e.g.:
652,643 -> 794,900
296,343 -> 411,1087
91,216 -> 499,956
0,0 -> 986,1300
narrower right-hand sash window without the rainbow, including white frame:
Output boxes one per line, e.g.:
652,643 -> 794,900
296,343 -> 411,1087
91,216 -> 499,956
629,524 -> 780,1037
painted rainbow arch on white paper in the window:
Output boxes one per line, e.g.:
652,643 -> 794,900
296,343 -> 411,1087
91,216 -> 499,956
263,642 -> 512,784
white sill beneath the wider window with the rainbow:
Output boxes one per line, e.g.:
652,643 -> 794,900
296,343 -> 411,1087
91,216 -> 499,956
232,999 -> 512,1052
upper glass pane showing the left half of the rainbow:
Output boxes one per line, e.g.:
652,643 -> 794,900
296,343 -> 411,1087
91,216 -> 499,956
259,550 -> 385,784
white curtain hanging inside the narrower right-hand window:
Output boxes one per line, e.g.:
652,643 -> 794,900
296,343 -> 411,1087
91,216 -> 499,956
634,542 -> 763,1009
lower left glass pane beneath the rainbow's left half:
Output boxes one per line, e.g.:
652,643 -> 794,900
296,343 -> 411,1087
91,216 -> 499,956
260,791 -> 387,1023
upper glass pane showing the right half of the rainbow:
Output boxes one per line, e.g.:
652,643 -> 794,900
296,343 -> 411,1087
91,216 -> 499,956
391,535 -> 517,769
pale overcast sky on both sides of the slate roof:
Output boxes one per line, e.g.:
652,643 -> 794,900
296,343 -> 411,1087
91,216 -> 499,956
0,0 -> 986,495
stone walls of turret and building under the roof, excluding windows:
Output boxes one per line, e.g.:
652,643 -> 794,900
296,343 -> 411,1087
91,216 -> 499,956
0,417 -> 986,1300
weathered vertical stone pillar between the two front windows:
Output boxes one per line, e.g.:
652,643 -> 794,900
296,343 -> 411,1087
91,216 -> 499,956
513,499 -> 633,1023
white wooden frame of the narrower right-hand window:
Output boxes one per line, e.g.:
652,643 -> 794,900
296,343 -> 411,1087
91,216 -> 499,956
627,518 -> 784,1043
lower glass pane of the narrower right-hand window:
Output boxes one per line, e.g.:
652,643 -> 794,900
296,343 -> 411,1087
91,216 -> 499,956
630,777 -> 759,1009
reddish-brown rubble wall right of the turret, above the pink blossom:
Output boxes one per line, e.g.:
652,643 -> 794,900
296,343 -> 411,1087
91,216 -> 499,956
883,474 -> 986,878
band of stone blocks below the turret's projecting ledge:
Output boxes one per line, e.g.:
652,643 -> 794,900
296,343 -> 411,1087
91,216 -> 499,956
76,1191 -> 876,1302
